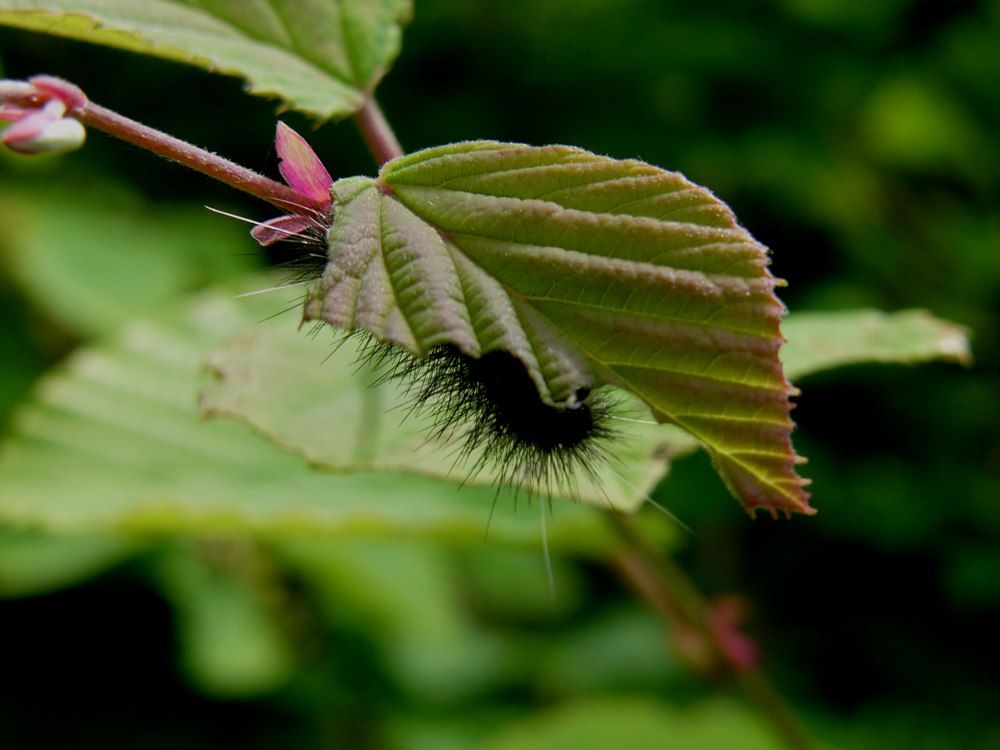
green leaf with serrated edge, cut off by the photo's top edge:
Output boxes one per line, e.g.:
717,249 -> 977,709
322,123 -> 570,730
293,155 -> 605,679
0,0 -> 412,119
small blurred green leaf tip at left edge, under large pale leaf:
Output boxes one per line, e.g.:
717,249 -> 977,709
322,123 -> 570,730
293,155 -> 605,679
0,528 -> 136,597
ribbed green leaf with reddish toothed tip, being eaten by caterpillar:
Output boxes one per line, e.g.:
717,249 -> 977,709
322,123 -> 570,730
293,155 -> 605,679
305,142 -> 812,514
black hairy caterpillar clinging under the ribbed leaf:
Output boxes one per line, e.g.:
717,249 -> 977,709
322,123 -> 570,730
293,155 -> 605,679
362,337 -> 616,495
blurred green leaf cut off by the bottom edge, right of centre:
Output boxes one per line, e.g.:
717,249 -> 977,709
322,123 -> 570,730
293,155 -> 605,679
479,698 -> 782,750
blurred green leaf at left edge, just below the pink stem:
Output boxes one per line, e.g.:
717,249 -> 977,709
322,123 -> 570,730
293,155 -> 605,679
0,177 -> 254,335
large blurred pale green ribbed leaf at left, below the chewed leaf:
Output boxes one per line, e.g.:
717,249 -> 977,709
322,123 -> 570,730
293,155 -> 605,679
0,280 -> 652,552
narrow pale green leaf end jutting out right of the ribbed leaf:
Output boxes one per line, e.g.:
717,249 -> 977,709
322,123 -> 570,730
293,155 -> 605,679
781,310 -> 972,378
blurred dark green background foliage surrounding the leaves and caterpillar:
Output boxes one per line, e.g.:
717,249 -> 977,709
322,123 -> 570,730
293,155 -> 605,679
0,0 -> 1000,749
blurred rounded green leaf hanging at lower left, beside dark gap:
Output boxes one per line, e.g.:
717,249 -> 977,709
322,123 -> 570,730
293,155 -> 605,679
157,542 -> 294,698
